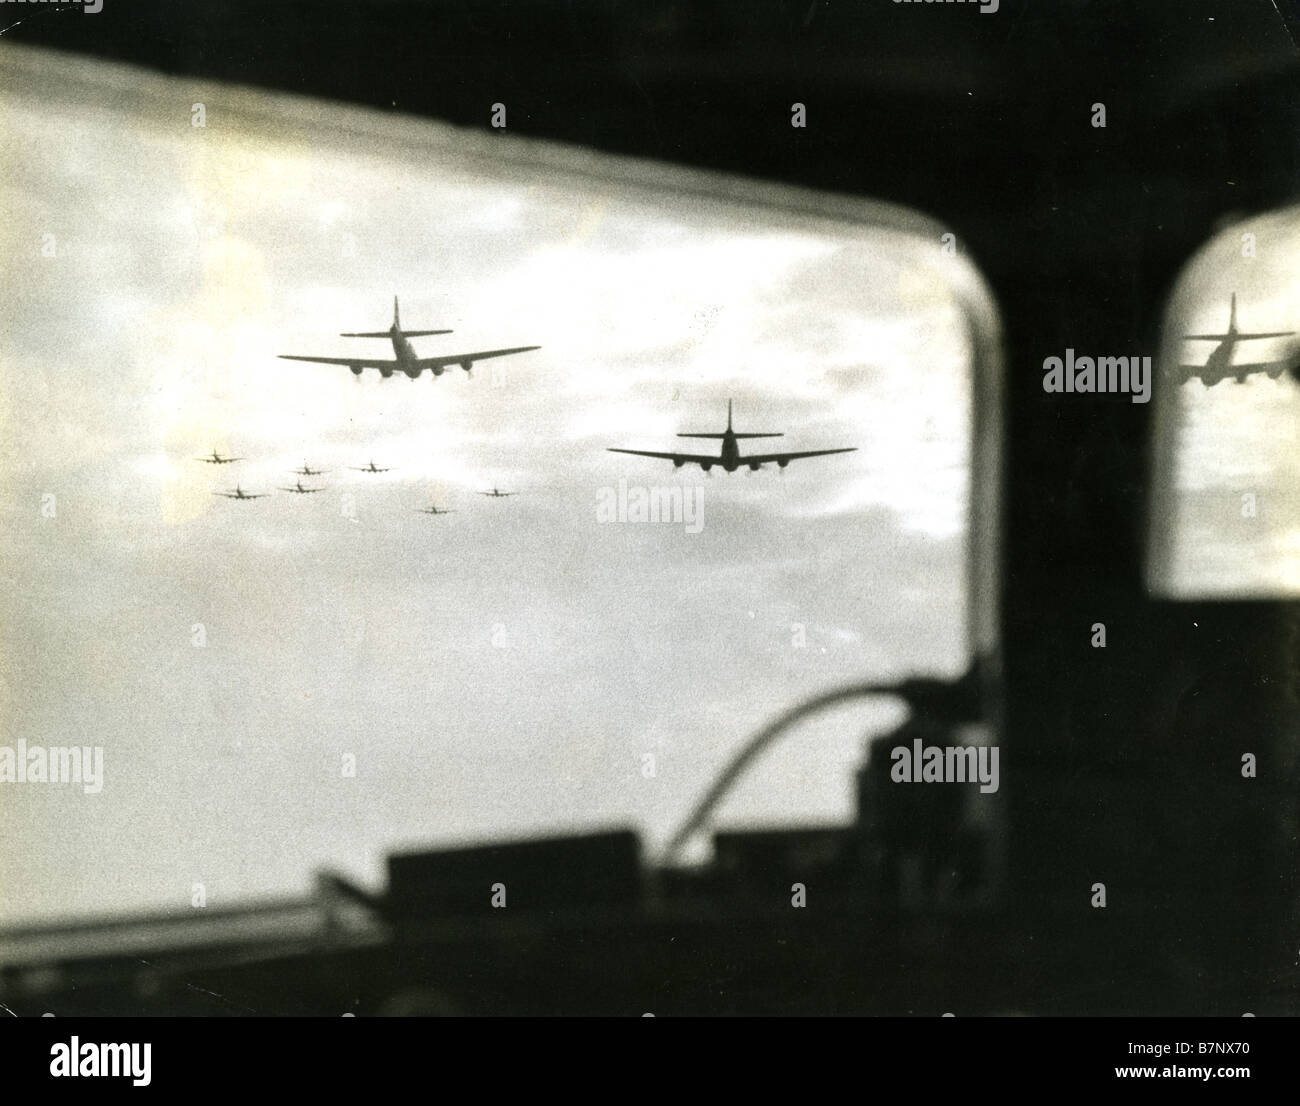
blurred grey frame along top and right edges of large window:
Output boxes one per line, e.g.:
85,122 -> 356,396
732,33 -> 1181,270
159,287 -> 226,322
17,36 -> 1005,668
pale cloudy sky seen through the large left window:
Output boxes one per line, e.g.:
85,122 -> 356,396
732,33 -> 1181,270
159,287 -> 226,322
0,48 -> 977,920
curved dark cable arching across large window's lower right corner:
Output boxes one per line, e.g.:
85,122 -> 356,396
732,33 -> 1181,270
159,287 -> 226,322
663,668 -> 979,867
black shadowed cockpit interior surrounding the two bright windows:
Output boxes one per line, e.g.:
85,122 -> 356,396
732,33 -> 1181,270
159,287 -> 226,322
0,0 -> 1300,1016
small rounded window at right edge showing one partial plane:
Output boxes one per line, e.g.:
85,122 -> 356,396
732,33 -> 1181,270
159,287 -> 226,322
1148,208 -> 1300,598
